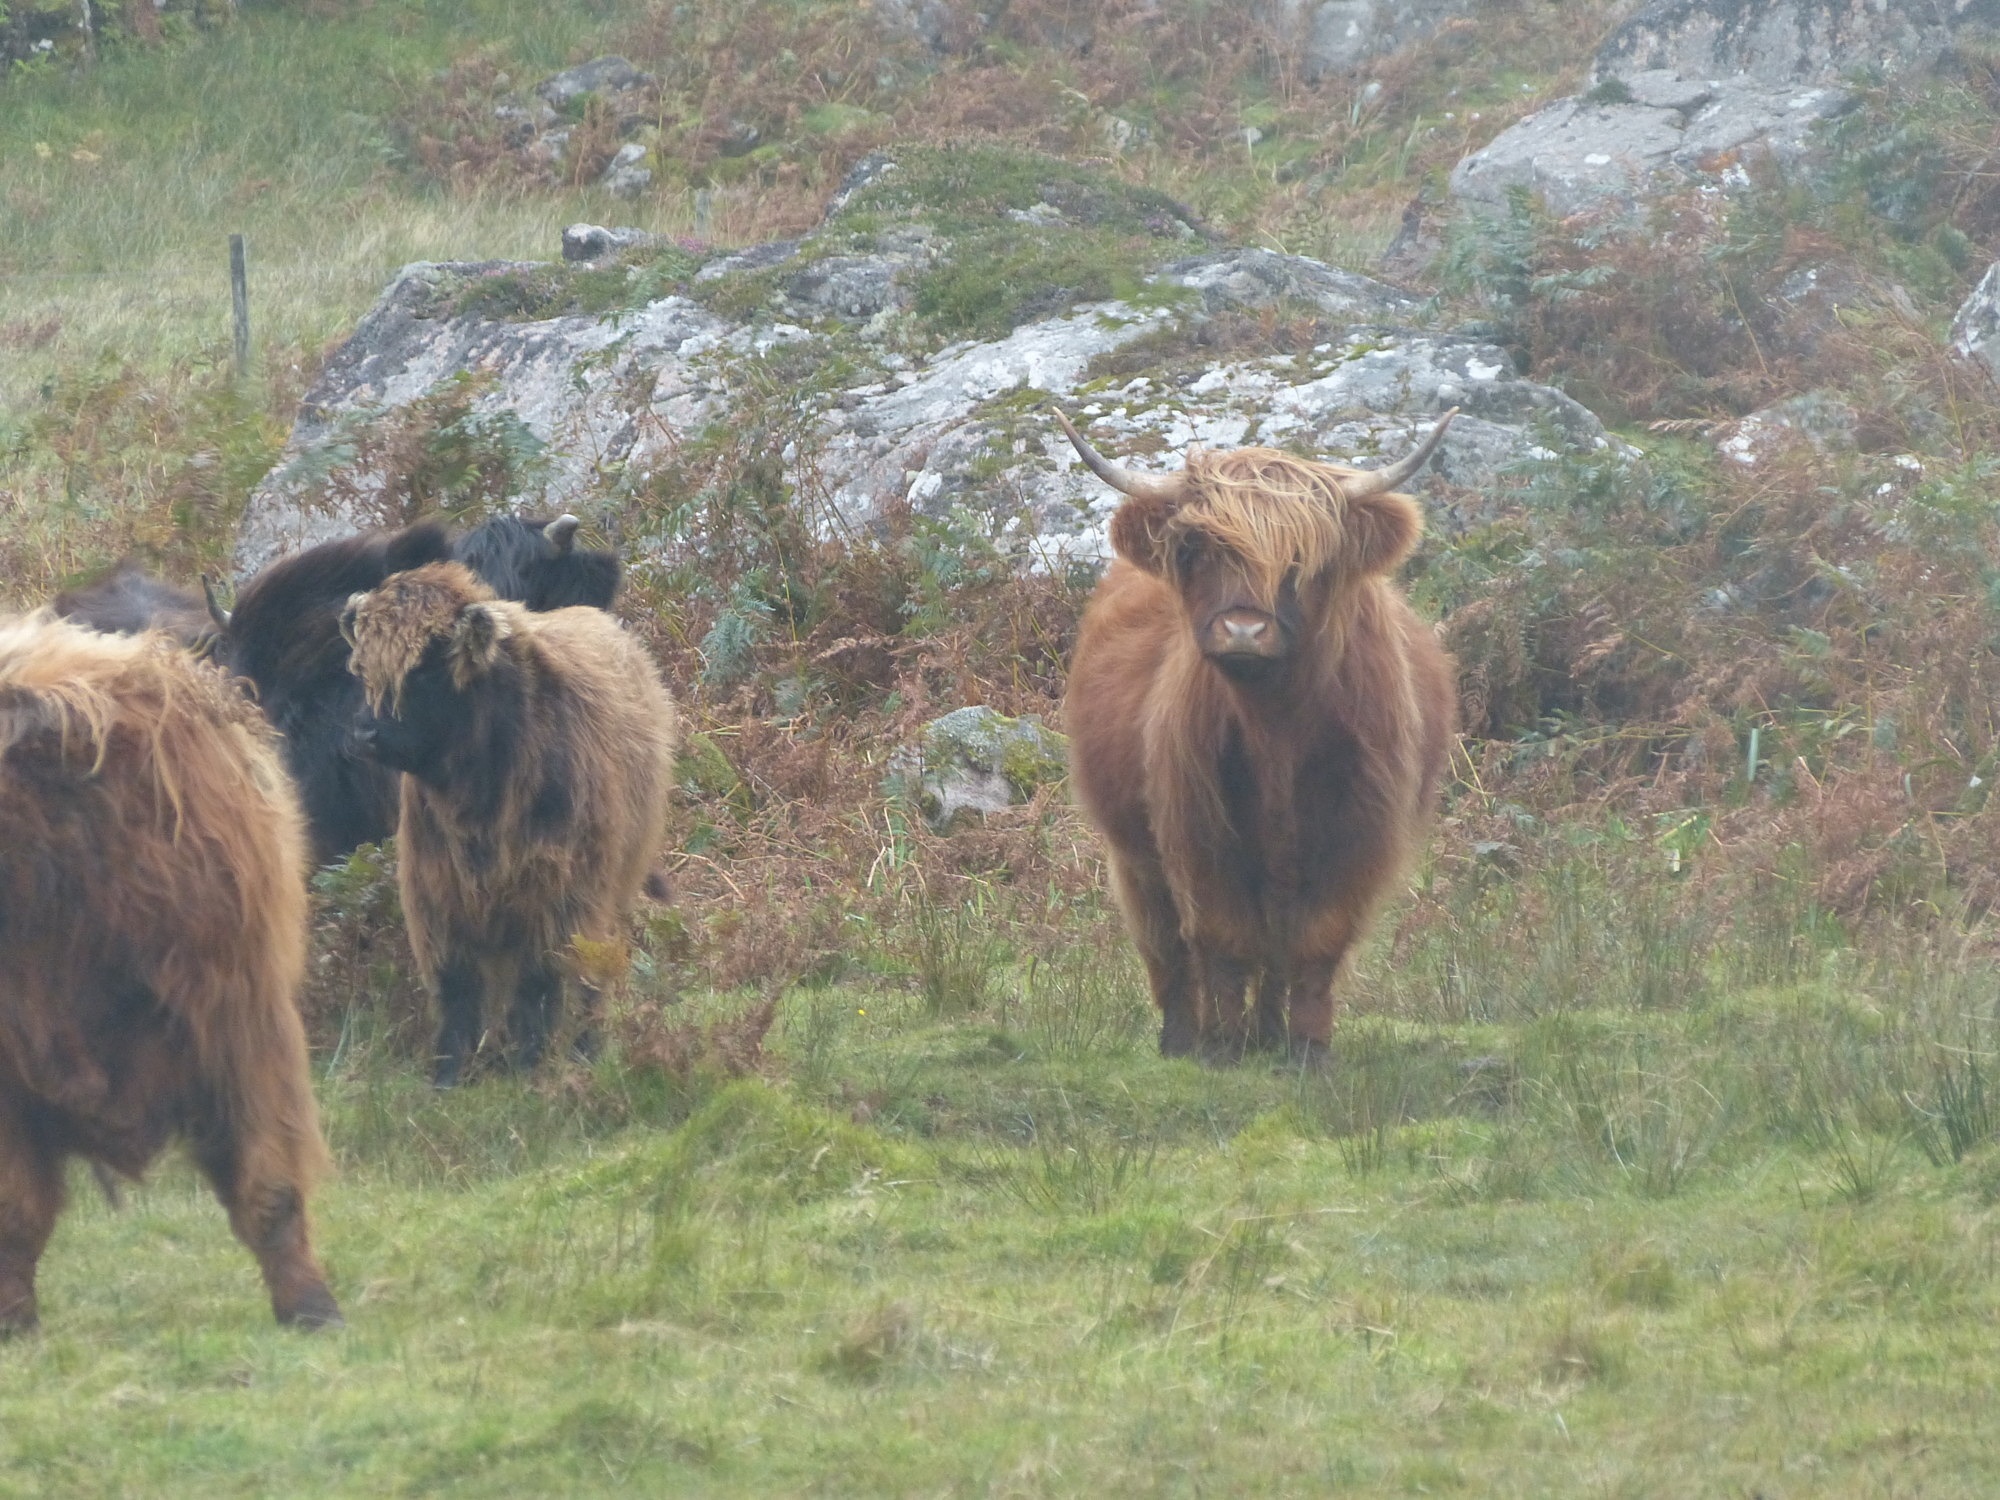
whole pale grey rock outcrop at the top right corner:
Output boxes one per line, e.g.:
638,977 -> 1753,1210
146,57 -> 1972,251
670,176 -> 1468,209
1452,0 -> 2000,214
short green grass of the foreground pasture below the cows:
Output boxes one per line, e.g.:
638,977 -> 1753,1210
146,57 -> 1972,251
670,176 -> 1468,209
11,948 -> 2000,1496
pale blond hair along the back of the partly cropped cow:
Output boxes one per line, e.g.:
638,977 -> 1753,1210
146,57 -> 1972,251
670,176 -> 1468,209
0,610 -> 276,840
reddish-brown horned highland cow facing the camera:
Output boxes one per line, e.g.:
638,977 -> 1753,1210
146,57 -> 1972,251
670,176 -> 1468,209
1058,412 -> 1454,1058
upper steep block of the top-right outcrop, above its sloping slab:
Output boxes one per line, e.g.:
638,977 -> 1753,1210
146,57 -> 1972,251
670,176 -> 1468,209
1596,0 -> 2000,90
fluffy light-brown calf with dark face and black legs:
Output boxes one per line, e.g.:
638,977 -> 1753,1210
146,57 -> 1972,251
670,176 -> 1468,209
340,562 -> 678,1086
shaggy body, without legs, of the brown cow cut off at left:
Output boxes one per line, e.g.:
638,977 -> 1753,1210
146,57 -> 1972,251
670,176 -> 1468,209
0,618 -> 306,1136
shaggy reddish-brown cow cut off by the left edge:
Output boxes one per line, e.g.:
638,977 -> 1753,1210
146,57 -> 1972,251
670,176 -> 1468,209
0,616 -> 340,1332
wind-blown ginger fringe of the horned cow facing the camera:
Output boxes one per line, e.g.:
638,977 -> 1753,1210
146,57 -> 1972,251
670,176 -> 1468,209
1160,448 -> 1384,600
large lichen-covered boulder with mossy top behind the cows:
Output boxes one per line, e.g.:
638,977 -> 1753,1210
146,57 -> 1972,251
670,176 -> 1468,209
236,148 -> 1610,572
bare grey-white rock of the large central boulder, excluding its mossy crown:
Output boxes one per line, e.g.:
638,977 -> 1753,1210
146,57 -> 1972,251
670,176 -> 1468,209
236,173 -> 1632,570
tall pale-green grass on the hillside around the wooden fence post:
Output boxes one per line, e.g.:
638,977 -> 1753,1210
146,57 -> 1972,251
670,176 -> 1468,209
0,0 -> 690,406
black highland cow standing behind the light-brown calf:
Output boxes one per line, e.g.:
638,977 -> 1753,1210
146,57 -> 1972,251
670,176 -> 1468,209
216,516 -> 620,864
